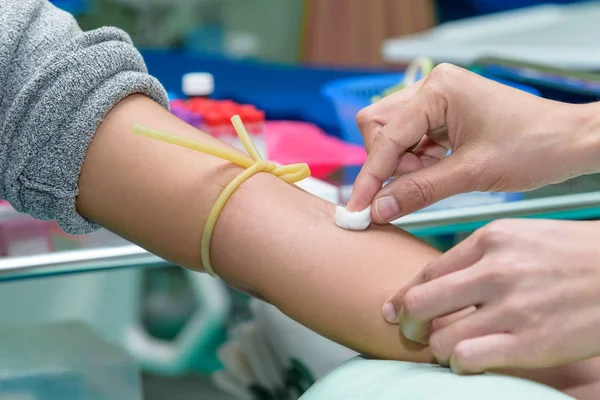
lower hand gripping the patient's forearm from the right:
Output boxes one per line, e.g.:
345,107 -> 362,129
383,220 -> 600,373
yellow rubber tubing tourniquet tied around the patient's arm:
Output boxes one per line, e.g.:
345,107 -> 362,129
131,115 -> 310,277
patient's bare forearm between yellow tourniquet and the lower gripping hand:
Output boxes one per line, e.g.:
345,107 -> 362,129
214,176 -> 438,361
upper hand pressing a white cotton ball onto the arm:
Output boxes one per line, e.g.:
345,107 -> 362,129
348,64 -> 600,224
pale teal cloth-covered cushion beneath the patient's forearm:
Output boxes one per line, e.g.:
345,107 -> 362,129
301,358 -> 572,400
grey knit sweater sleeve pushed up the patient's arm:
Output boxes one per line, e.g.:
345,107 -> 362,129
0,0 -> 168,234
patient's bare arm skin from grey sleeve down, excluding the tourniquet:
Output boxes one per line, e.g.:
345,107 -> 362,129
77,95 -> 600,396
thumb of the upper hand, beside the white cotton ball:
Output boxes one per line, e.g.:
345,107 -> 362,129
372,154 -> 477,224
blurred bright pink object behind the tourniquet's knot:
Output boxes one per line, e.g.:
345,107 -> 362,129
265,121 -> 367,179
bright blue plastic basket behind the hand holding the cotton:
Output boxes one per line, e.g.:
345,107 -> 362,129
322,73 -> 540,145
